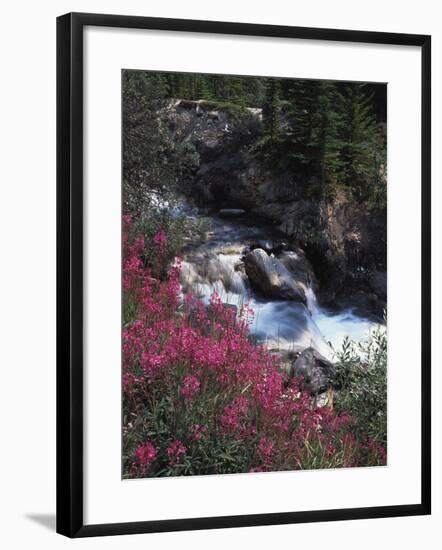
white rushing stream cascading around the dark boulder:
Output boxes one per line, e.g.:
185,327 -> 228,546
178,203 -> 377,359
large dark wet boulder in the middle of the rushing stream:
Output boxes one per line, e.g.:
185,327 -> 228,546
244,248 -> 306,303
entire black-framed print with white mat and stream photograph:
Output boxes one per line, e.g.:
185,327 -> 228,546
57,13 -> 431,537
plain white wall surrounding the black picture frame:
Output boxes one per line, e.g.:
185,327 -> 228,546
0,0 -> 442,550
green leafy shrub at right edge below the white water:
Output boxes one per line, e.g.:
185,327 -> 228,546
337,328 -> 387,445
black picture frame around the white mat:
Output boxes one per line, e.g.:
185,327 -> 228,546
56,13 -> 431,537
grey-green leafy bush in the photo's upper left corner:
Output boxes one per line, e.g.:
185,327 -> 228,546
122,71 -> 198,216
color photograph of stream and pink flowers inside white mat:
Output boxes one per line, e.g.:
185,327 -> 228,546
121,69 -> 387,479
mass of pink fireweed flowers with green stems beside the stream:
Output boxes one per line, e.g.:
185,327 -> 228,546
123,215 -> 386,478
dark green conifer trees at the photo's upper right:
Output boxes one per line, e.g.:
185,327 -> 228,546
256,79 -> 386,208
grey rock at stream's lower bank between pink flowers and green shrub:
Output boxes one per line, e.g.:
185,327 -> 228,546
290,347 -> 336,395
